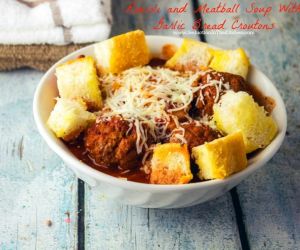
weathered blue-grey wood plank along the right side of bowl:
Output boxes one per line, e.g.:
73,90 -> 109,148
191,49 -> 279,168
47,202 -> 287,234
201,0 -> 300,249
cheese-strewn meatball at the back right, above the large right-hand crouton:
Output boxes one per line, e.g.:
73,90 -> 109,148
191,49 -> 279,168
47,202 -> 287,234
192,71 -> 247,116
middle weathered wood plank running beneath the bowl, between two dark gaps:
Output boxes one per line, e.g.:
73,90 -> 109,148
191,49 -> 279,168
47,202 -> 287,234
85,1 -> 241,249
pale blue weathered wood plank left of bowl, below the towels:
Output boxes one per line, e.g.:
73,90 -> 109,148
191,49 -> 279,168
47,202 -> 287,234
0,69 -> 77,249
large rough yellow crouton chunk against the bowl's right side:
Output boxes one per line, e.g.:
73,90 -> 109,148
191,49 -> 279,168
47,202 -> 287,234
213,91 -> 277,153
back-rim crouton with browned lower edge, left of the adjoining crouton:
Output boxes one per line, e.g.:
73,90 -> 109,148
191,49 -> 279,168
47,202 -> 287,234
166,38 -> 212,71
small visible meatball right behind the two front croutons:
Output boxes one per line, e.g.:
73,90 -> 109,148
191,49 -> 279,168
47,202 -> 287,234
170,122 -> 220,150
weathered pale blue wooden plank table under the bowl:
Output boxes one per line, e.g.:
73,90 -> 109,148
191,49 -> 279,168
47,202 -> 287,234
0,0 -> 300,249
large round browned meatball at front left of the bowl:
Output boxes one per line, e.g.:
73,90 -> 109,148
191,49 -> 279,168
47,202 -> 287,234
84,117 -> 139,169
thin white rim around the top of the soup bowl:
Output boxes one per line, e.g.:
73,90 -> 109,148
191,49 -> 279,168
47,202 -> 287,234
33,35 -> 287,192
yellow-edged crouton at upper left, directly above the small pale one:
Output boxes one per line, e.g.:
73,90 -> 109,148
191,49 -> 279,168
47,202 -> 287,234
56,56 -> 102,110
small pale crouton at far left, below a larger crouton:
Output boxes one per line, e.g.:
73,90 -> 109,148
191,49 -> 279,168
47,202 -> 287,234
47,98 -> 96,141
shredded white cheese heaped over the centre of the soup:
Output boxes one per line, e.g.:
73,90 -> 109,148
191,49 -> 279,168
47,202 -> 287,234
100,66 -> 226,153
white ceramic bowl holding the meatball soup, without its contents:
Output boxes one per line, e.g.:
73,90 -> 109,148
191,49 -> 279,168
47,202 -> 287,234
33,36 -> 287,208
